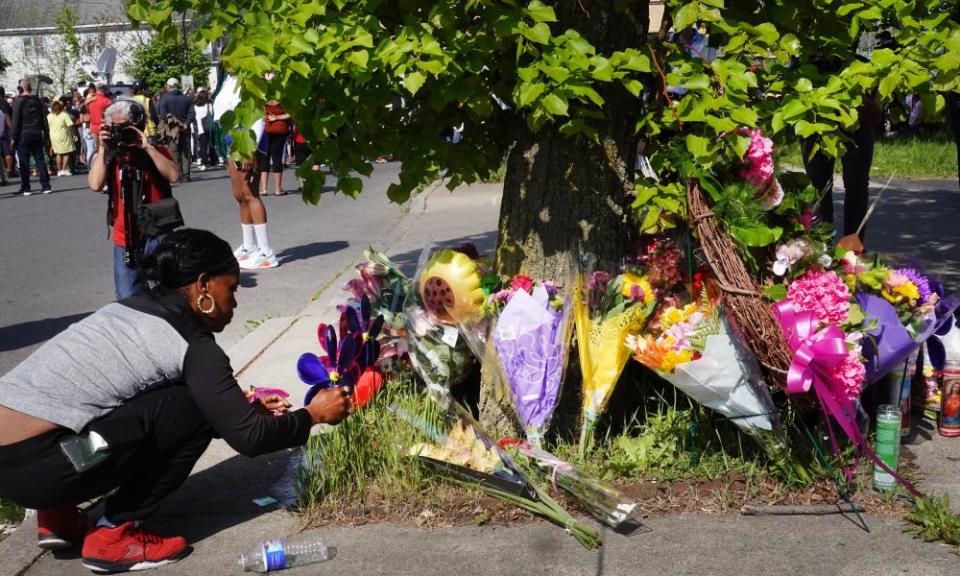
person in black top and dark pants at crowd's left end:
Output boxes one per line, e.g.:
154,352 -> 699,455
11,80 -> 53,196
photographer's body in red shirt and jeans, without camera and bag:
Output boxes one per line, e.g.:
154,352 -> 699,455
87,98 -> 180,300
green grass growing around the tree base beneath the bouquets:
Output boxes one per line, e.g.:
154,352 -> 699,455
296,379 -> 824,512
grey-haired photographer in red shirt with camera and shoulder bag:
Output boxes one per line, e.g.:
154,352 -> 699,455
87,99 -> 183,299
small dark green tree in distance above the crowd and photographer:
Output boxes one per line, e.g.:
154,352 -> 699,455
126,30 -> 210,92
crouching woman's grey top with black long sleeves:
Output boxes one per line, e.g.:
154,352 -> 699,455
0,293 -> 311,456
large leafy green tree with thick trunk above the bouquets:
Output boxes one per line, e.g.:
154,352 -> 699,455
128,0 -> 960,432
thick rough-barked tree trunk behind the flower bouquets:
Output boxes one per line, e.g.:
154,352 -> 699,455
480,0 -> 649,434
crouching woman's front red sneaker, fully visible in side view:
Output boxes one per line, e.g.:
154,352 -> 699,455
83,522 -> 190,574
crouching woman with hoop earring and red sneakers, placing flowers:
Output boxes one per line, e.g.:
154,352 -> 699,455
0,230 -> 349,572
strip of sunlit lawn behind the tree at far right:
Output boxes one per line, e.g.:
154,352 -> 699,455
781,132 -> 957,180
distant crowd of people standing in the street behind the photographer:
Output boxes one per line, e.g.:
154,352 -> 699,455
0,78 -> 304,196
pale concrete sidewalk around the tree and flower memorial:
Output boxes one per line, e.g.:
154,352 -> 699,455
0,181 -> 960,576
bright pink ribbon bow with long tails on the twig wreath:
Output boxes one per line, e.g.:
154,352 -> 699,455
771,300 -> 920,496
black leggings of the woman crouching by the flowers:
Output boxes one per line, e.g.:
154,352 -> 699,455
0,385 -> 213,523
